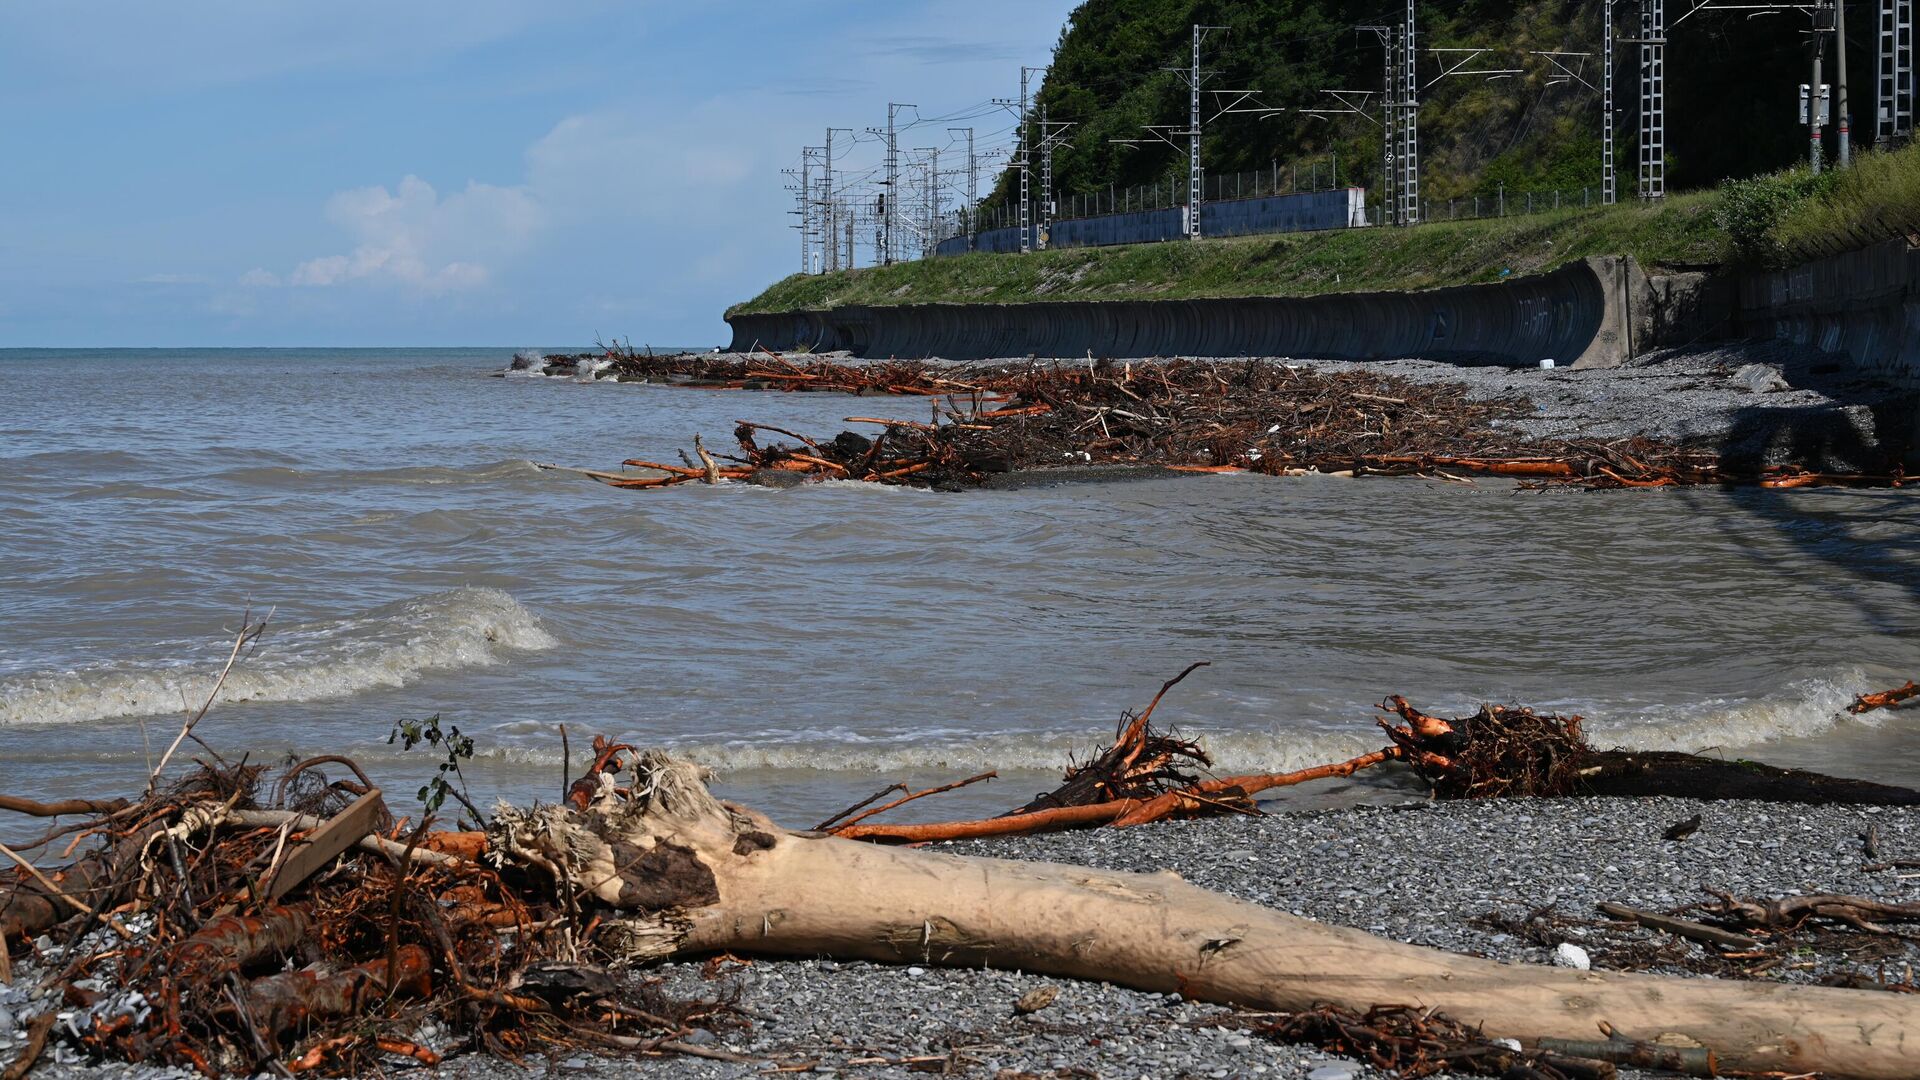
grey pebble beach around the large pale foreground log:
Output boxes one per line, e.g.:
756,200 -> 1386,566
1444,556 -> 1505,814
11,799 -> 1920,1080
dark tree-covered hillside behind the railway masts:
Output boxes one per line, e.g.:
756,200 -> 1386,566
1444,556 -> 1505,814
987,0 -> 1872,212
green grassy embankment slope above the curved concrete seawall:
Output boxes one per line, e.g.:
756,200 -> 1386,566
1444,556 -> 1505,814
733,146 -> 1920,311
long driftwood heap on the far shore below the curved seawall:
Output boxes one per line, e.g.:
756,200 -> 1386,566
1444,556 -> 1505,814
537,352 -> 1905,488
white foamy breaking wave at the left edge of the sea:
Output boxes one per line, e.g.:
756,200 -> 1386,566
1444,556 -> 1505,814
0,588 -> 559,728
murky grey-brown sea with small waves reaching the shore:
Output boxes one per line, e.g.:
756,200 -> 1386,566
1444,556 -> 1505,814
0,344 -> 1920,836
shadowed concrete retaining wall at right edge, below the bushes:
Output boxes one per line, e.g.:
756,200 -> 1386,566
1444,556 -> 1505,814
1734,240 -> 1920,390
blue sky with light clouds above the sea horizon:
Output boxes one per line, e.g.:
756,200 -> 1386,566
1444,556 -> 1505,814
0,0 -> 1075,348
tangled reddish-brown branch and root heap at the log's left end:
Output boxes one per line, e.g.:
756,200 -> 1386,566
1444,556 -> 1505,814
0,757 -> 737,1076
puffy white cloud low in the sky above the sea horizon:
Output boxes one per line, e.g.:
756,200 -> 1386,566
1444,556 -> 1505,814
255,175 -> 545,294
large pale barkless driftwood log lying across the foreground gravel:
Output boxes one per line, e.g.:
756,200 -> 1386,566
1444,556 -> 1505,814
492,753 -> 1920,1080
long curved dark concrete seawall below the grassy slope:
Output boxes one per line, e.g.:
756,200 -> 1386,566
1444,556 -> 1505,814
728,258 -> 1634,367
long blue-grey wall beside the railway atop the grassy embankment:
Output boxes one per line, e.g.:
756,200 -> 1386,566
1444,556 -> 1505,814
935,188 -> 1367,256
